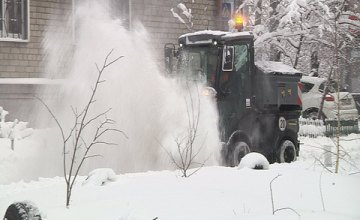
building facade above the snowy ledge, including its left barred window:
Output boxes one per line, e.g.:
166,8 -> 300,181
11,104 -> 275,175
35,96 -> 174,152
0,0 -> 233,78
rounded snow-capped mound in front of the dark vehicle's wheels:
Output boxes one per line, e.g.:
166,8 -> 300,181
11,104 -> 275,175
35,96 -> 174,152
238,152 -> 269,170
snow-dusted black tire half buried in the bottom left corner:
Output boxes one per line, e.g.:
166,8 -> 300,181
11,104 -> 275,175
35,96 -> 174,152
4,202 -> 41,220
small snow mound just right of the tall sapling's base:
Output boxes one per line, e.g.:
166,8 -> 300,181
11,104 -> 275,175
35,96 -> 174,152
82,168 -> 116,186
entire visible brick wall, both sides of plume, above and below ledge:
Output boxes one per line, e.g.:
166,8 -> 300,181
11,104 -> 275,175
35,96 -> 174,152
0,0 -> 225,126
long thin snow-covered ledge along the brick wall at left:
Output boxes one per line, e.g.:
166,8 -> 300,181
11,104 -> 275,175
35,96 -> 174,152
0,78 -> 64,85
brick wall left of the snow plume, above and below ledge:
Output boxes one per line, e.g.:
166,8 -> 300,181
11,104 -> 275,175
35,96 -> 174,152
0,0 -> 71,126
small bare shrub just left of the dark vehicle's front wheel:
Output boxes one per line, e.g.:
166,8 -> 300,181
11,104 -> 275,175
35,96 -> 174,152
162,84 -> 210,177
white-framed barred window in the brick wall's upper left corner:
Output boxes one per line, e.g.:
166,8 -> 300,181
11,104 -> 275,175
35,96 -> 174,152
0,0 -> 29,40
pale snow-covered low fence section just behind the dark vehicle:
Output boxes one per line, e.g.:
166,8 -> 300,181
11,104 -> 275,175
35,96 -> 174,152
298,117 -> 326,137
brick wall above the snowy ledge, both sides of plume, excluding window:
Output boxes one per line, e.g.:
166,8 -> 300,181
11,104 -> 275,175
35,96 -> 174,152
0,0 -> 224,78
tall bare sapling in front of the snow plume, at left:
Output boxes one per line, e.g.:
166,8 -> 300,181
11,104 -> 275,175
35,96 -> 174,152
38,50 -> 126,207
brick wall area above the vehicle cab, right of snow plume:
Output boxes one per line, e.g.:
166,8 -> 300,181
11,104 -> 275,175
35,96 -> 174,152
130,0 -> 223,60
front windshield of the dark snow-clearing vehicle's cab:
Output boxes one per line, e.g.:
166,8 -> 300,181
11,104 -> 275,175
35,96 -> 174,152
179,46 -> 218,86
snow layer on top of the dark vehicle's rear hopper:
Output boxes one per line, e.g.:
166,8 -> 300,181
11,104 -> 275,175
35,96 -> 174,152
255,61 -> 301,75
